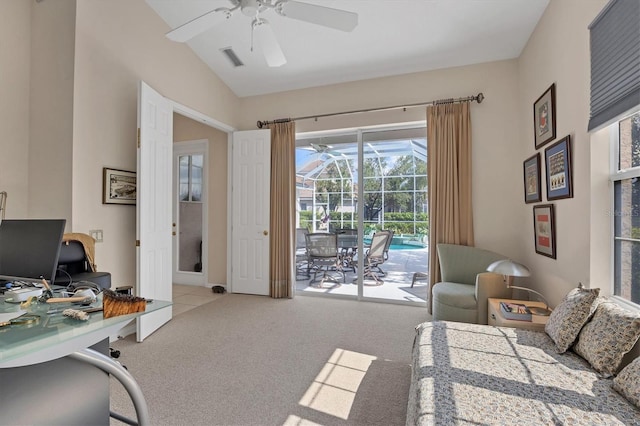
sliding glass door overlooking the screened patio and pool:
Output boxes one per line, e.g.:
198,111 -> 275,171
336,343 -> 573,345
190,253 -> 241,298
296,127 -> 428,304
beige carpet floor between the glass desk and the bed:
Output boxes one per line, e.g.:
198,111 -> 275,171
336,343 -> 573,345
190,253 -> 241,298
111,294 -> 430,426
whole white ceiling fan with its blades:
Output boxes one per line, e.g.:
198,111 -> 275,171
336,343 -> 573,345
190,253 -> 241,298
166,0 -> 358,67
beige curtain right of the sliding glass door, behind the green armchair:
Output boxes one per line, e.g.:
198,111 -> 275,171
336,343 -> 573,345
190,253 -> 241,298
427,102 -> 474,312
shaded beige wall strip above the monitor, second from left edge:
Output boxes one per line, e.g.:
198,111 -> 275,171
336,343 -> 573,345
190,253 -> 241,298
28,0 -> 76,225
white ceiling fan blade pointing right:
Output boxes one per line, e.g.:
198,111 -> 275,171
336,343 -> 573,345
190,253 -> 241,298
276,0 -> 358,32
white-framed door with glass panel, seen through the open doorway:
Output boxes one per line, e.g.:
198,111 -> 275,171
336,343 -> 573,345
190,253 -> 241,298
173,140 -> 208,286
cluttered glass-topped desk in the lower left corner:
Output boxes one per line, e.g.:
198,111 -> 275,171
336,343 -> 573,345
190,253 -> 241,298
0,297 -> 171,425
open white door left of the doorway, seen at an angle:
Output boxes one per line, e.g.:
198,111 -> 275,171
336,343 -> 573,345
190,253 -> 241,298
136,81 -> 173,342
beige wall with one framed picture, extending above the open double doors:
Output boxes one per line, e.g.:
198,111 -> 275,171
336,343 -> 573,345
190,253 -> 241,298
70,0 -> 238,286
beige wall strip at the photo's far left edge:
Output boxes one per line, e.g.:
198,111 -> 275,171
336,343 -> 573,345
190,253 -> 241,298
0,0 -> 31,218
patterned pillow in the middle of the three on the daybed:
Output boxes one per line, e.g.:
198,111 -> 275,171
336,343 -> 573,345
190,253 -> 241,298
573,302 -> 640,377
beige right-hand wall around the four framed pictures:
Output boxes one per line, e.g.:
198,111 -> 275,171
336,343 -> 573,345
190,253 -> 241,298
509,0 -> 610,304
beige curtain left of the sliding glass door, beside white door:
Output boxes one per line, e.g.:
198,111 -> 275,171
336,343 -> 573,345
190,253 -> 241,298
269,122 -> 296,299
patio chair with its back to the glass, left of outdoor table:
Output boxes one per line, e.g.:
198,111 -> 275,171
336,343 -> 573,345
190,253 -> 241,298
305,232 -> 346,288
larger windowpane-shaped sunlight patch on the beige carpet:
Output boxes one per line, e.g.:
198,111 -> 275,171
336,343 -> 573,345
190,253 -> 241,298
299,348 -> 377,420
